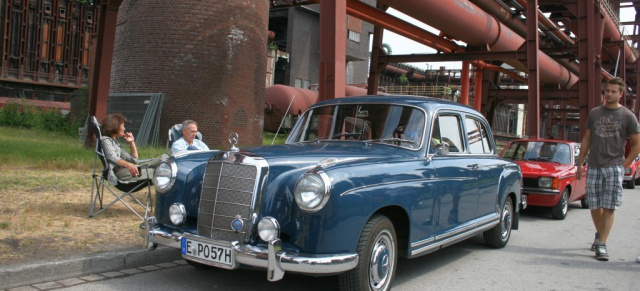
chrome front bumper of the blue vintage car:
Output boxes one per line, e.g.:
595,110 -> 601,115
140,217 -> 358,281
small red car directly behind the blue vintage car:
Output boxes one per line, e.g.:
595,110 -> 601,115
500,139 -> 588,219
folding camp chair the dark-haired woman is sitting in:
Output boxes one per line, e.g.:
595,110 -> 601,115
89,116 -> 152,220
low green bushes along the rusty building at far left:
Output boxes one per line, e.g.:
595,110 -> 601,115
0,98 -> 83,136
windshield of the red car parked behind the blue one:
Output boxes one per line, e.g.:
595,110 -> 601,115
502,141 -> 572,164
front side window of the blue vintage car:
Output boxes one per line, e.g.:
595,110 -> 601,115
429,114 -> 465,154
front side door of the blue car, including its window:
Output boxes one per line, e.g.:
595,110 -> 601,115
430,112 -> 477,240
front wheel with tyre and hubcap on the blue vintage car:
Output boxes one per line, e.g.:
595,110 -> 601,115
339,215 -> 398,291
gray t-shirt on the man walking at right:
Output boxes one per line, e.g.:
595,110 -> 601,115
587,105 -> 640,168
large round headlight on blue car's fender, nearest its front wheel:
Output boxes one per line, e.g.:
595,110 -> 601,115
294,172 -> 331,212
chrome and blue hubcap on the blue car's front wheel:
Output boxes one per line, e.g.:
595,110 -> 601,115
369,231 -> 395,290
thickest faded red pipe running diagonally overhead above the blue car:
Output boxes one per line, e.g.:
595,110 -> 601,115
379,0 -> 578,88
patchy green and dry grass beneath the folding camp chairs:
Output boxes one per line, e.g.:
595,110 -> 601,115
0,126 -> 285,265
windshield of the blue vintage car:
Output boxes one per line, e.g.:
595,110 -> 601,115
287,104 -> 425,149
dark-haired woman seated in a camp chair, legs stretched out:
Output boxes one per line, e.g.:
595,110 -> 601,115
100,113 -> 169,185
